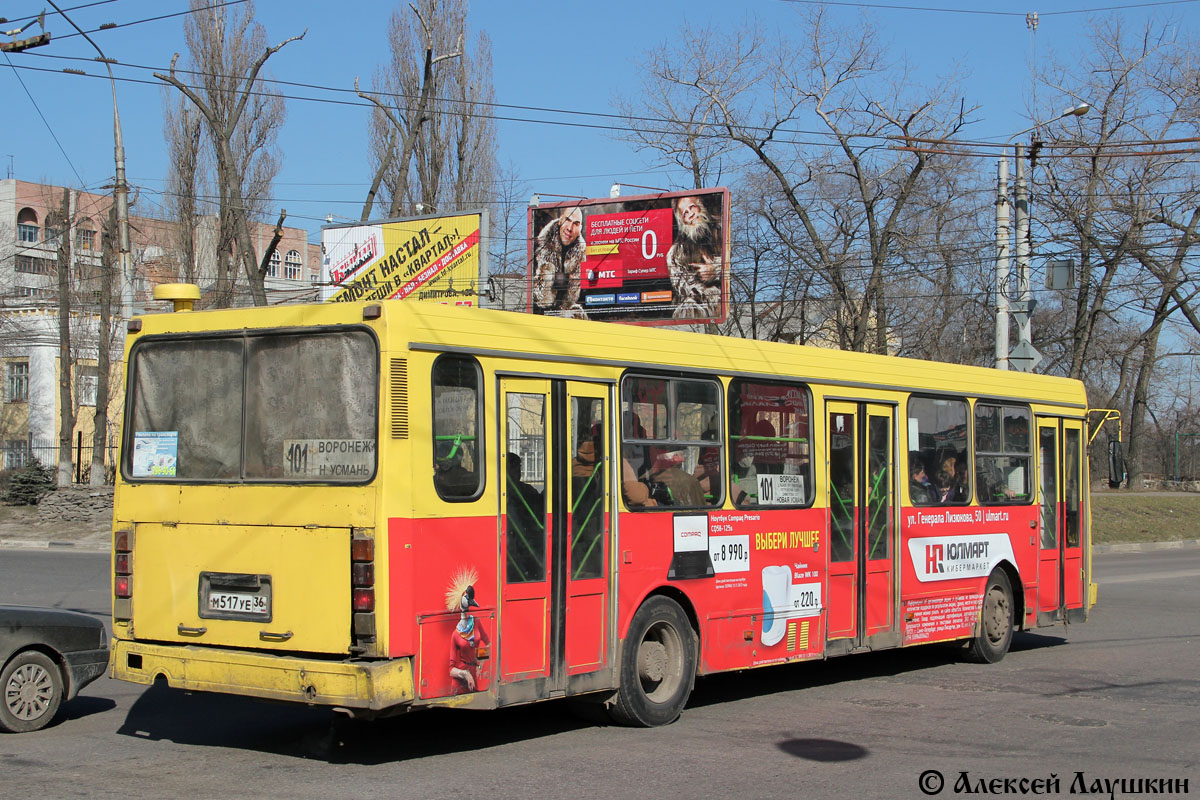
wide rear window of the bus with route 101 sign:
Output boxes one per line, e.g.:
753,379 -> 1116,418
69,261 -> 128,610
129,331 -> 379,483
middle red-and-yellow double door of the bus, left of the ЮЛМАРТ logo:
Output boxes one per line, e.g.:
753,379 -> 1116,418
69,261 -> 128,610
826,401 -> 896,651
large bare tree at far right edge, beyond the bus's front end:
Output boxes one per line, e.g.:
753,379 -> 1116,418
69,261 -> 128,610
1033,18 -> 1200,485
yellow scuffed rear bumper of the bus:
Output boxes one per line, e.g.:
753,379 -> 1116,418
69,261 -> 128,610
108,639 -> 414,711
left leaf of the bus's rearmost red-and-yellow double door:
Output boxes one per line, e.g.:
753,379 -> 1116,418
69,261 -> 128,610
496,378 -> 557,686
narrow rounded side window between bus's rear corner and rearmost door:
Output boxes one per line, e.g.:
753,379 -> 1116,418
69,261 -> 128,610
433,355 -> 484,501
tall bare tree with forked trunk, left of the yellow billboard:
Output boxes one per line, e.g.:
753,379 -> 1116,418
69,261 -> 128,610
155,0 -> 307,306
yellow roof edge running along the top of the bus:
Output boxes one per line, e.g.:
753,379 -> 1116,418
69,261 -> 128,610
129,301 -> 1087,409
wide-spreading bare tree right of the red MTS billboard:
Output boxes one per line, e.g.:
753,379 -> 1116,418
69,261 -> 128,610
630,10 -> 973,351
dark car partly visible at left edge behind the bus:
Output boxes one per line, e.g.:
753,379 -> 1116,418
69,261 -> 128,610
0,606 -> 108,733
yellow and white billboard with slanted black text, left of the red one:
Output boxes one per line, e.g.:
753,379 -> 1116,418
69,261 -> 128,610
320,210 -> 487,306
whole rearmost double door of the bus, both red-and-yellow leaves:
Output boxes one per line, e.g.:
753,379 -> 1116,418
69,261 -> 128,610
497,378 -> 612,704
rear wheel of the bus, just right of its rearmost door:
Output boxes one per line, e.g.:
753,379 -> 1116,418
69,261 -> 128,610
608,595 -> 696,728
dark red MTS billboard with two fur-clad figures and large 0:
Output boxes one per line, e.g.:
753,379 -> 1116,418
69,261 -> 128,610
529,188 -> 730,325
